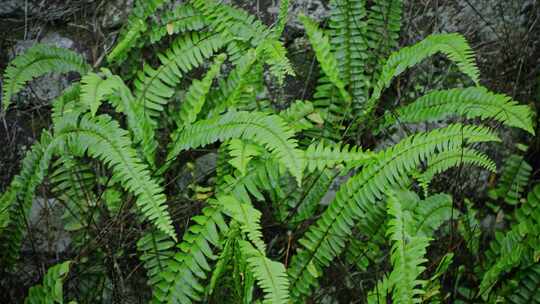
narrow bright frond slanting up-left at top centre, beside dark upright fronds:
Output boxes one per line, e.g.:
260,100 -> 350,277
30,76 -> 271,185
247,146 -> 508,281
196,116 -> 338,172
299,15 -> 351,102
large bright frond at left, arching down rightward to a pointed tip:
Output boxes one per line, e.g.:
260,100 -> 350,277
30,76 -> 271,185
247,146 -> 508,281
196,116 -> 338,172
54,113 -> 176,239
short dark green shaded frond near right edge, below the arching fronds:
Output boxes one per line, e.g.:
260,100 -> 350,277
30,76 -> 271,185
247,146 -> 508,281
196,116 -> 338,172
492,154 -> 532,205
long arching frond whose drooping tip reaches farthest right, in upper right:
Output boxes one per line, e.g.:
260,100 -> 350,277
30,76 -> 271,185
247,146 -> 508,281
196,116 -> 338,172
384,87 -> 534,135
